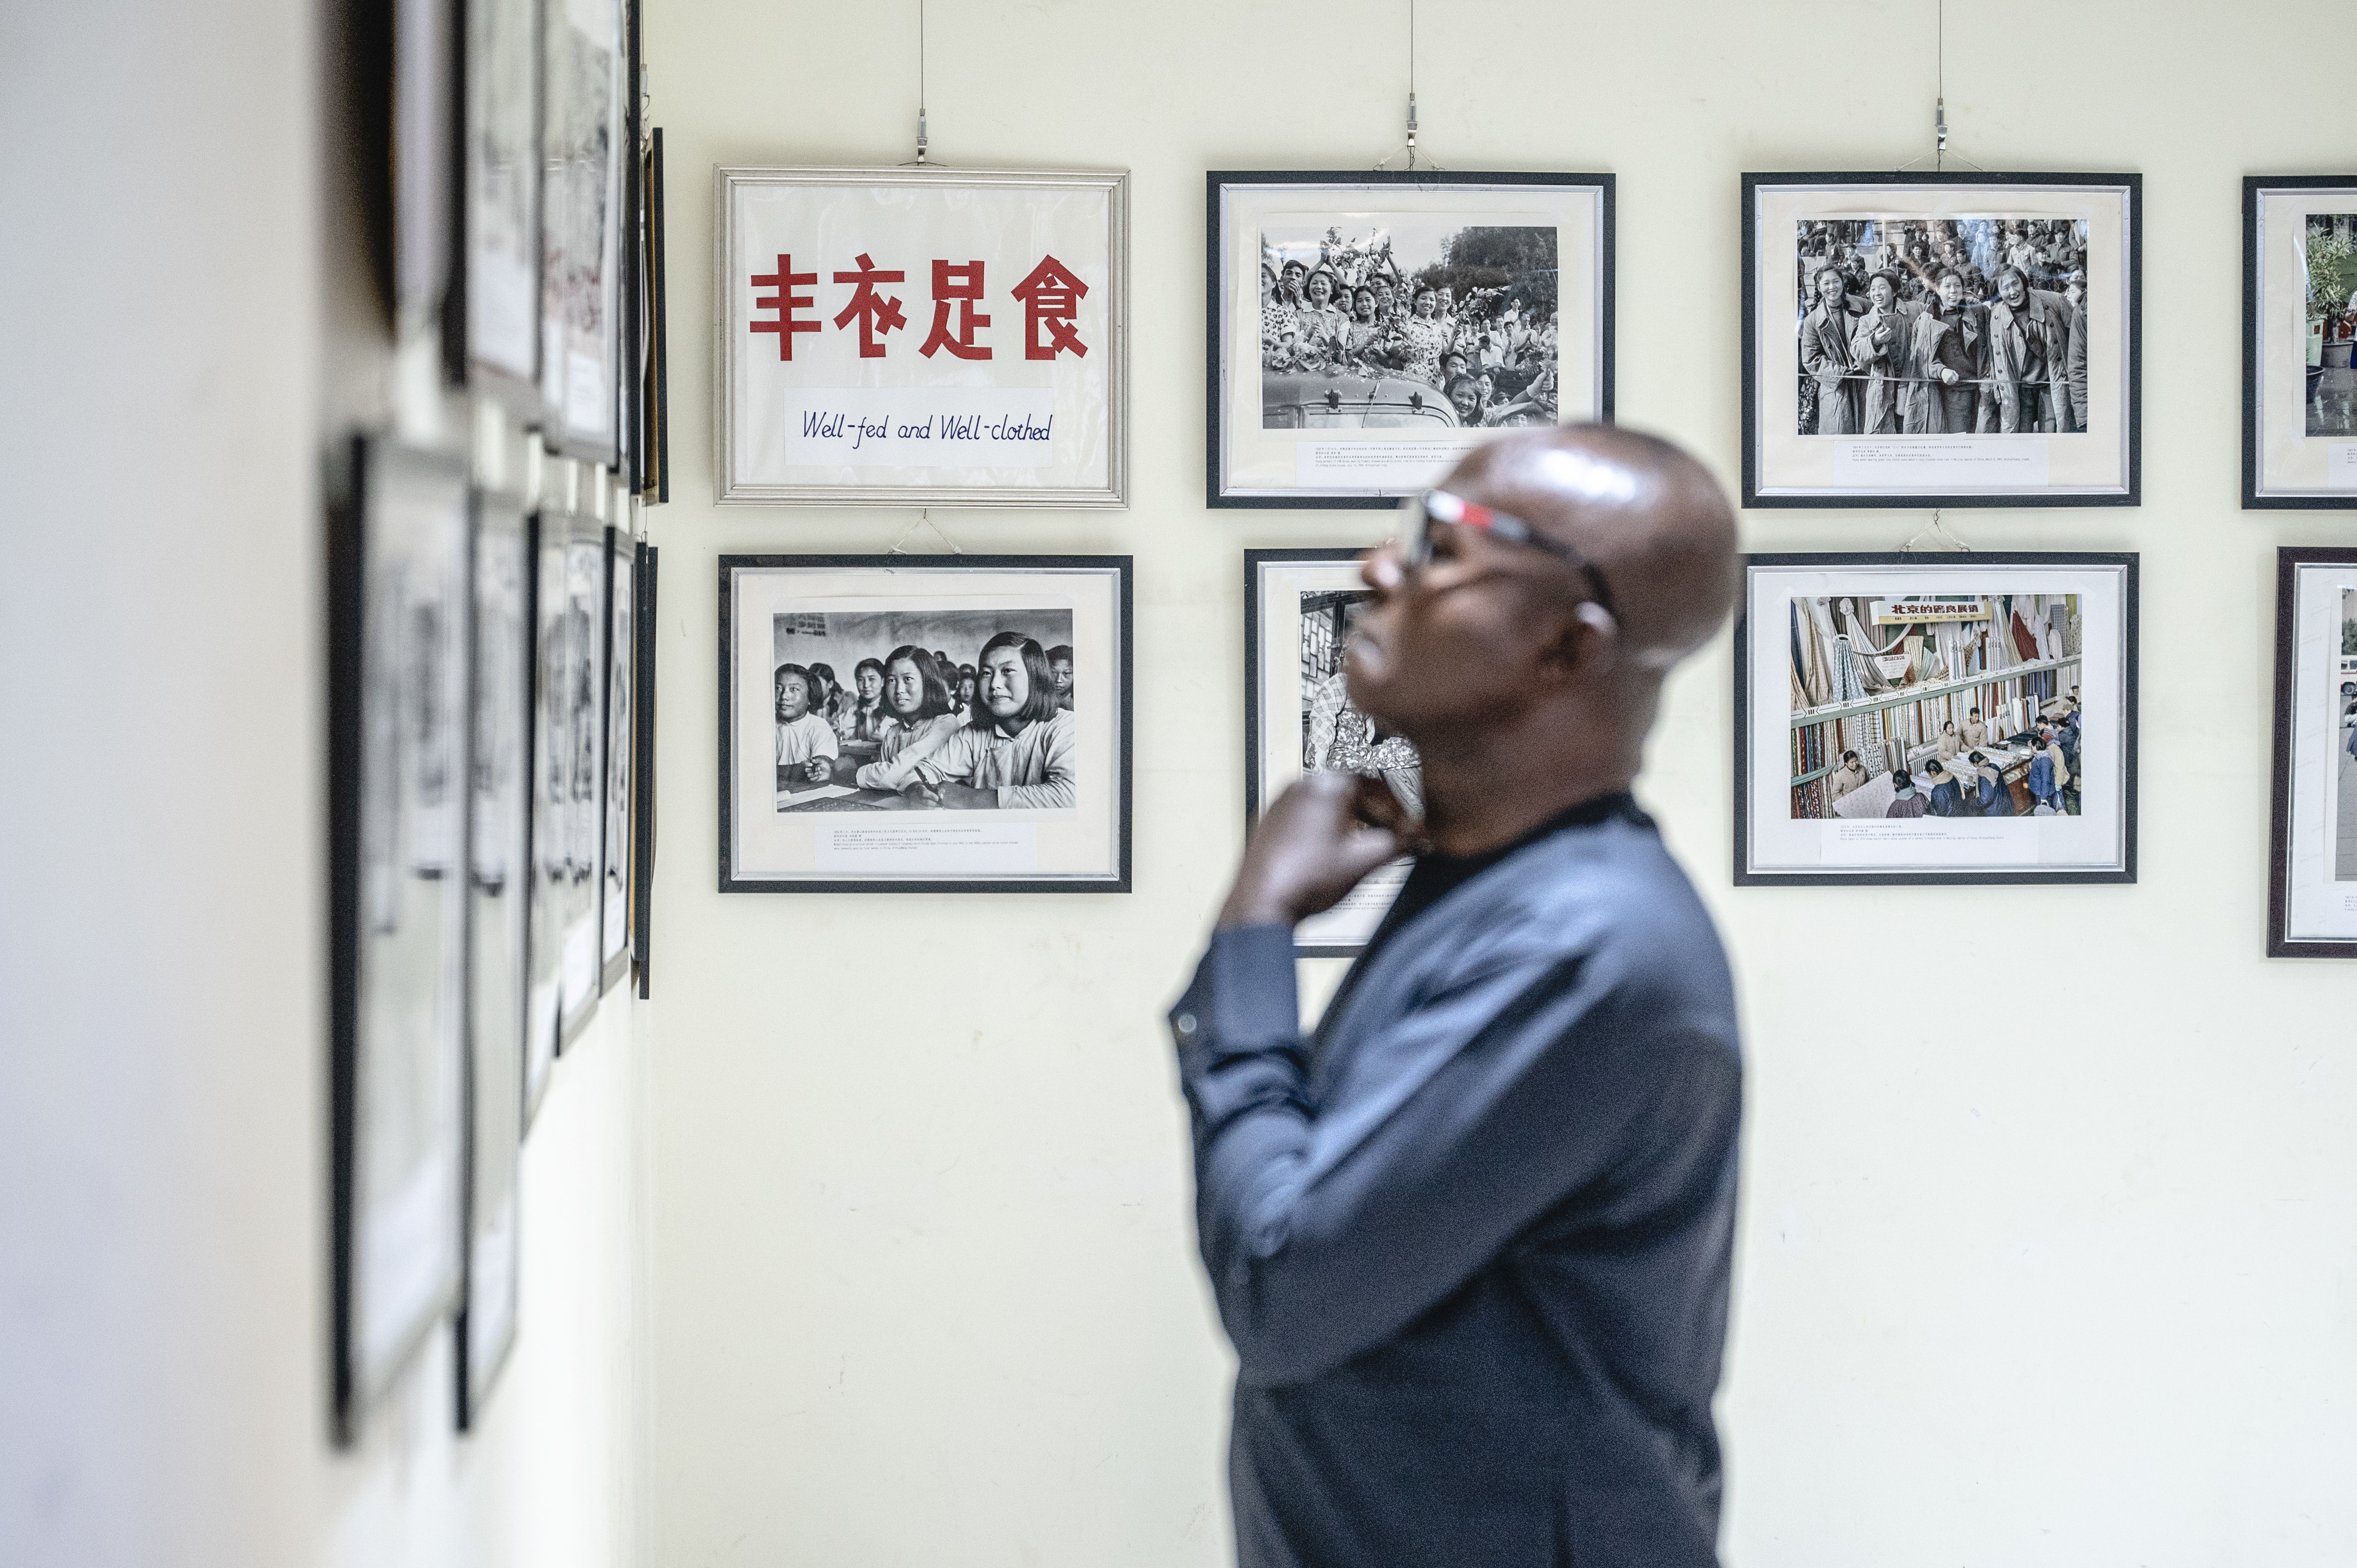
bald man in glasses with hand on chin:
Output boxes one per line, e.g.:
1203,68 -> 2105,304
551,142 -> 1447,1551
1171,427 -> 1742,1568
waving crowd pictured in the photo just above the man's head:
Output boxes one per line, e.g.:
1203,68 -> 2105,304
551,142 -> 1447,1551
1261,226 -> 1558,427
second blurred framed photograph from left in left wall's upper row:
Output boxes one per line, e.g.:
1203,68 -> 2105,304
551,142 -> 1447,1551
443,0 -> 542,410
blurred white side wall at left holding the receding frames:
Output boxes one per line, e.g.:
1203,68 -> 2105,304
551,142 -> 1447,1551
0,0 -> 650,1568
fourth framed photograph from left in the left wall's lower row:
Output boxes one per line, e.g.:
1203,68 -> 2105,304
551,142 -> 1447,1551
556,502 -> 606,1049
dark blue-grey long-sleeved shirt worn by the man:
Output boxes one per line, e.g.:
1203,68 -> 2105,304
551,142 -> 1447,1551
1171,795 -> 1742,1568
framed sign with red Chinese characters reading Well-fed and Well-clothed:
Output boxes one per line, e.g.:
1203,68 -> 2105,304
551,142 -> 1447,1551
714,165 -> 1129,507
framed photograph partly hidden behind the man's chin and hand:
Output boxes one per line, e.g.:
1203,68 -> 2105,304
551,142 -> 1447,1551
1245,549 -> 1423,958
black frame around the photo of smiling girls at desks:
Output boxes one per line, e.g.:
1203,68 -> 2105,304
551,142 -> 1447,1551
719,554 -> 1134,894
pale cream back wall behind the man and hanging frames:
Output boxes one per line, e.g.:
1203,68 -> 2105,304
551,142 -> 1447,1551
648,0 -> 2357,1568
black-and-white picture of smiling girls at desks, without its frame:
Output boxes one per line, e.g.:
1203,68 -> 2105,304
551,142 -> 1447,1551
771,608 -> 1079,811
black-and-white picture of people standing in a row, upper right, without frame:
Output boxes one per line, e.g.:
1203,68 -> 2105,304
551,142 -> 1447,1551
1796,217 -> 2088,436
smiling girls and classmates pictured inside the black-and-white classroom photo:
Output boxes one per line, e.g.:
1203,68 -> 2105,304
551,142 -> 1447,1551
773,630 -> 1075,811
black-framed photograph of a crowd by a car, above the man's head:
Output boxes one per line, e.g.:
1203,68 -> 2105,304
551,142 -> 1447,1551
1204,170 -> 1612,507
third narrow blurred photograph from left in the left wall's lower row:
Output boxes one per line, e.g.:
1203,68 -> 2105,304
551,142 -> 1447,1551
523,507 -> 573,1127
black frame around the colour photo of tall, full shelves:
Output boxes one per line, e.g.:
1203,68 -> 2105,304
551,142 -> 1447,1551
1732,549 -> 2140,887
